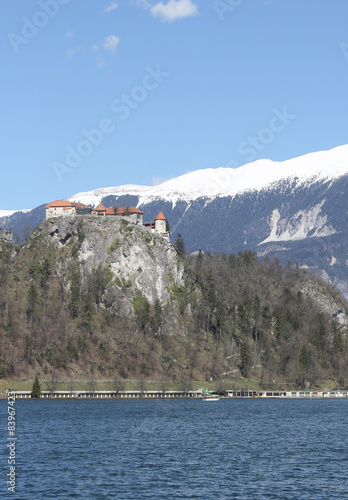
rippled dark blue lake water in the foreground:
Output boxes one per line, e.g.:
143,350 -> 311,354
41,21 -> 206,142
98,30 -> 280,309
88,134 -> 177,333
0,399 -> 348,500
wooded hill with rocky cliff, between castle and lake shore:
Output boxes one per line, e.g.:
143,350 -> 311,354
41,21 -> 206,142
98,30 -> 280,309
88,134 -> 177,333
0,217 -> 348,387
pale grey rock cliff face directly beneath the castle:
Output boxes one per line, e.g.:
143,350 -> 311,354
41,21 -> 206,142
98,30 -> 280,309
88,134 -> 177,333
42,216 -> 185,305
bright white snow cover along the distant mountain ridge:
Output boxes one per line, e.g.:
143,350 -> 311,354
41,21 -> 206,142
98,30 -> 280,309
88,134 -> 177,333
69,145 -> 348,206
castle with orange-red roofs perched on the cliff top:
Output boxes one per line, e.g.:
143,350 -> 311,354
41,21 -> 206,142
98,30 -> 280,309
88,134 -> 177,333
46,200 -> 170,240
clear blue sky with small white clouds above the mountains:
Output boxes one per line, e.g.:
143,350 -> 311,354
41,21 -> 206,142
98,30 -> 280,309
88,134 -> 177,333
0,0 -> 348,210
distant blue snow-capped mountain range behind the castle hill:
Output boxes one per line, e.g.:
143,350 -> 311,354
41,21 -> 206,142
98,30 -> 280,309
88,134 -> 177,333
0,145 -> 348,298
